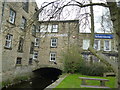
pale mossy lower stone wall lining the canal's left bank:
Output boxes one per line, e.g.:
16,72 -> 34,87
2,66 -> 33,87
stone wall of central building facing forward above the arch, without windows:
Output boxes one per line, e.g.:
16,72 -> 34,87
36,20 -> 79,67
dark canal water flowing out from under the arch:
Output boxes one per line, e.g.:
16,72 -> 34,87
2,68 -> 62,90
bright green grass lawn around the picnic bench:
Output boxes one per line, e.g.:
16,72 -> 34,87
56,74 -> 116,90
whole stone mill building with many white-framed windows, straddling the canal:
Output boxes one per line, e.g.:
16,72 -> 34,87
0,1 -> 118,87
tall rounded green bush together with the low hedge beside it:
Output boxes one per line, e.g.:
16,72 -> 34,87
62,45 -> 110,76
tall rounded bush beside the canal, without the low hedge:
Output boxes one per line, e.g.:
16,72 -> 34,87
62,45 -> 83,73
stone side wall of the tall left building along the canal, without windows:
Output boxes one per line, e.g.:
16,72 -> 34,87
0,2 -> 37,87
